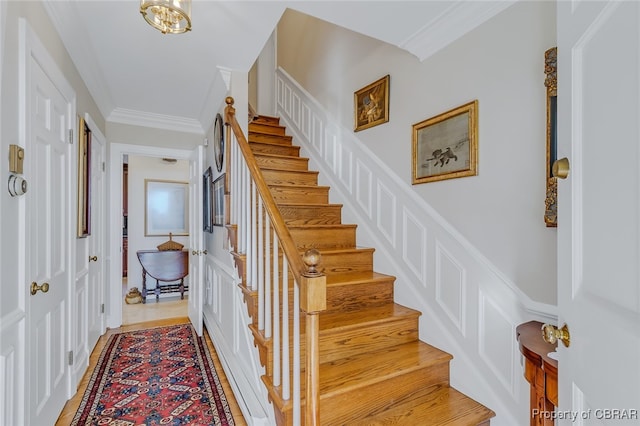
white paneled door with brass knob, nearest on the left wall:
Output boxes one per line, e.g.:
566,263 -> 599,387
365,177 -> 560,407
20,21 -> 76,425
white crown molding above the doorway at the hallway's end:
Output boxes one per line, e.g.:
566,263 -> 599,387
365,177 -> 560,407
107,108 -> 205,135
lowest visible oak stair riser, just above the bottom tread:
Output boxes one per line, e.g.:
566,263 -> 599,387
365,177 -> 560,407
320,362 -> 449,426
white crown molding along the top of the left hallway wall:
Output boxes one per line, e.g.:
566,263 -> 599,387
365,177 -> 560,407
43,0 -> 114,117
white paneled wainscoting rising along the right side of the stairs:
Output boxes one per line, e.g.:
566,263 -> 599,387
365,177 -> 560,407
276,69 -> 556,426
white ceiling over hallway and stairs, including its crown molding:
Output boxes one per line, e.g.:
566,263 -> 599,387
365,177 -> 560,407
44,0 -> 517,134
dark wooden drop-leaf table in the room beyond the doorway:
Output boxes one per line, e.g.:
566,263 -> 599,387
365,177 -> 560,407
137,250 -> 189,303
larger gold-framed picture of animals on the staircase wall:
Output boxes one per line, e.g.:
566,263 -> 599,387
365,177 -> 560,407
411,100 -> 478,185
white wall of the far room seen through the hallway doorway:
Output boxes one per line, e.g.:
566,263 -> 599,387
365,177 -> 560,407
127,155 -> 189,290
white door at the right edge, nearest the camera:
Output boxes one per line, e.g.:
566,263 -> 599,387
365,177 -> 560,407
554,1 -> 640,426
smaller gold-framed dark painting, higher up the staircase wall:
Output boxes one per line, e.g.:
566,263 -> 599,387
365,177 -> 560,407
353,75 -> 389,132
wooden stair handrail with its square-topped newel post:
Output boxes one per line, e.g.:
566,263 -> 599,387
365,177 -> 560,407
225,96 -> 327,426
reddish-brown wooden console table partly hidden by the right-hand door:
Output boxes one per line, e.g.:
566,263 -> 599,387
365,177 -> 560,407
516,321 -> 558,426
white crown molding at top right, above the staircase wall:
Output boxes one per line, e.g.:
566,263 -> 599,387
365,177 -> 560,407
398,0 -> 518,61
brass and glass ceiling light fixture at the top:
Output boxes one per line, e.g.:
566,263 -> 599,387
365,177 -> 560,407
140,0 -> 191,34
